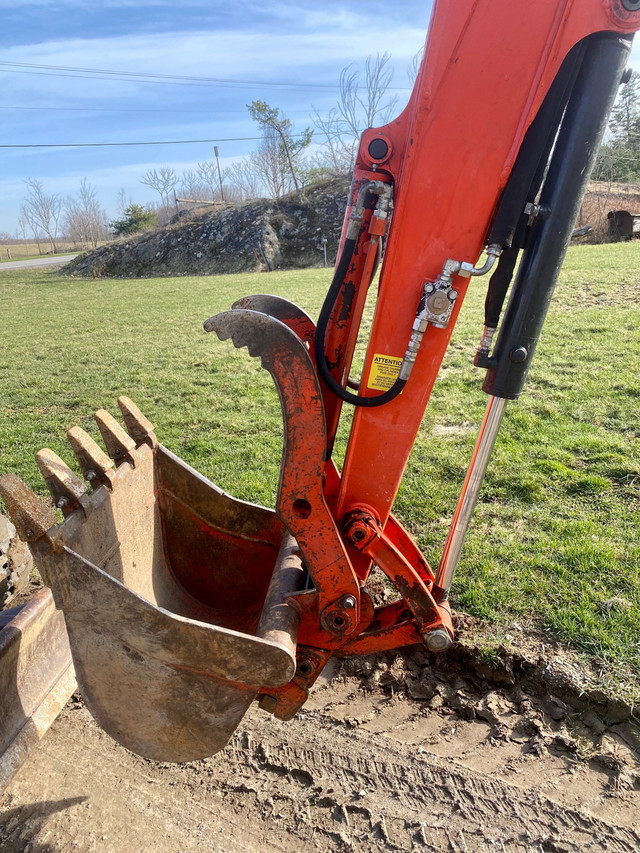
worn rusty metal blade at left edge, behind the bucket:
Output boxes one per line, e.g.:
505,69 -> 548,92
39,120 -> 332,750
0,588 -> 76,794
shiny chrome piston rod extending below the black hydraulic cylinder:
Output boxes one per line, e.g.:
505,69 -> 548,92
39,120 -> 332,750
435,397 -> 507,598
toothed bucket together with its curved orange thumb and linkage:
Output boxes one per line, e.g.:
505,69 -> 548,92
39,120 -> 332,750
0,386 -> 458,761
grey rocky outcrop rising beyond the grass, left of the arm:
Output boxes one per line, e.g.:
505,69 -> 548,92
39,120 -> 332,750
60,178 -> 349,278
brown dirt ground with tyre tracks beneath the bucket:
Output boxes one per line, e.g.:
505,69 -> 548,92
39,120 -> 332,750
0,616 -> 640,853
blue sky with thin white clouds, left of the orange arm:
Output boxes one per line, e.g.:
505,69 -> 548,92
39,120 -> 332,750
0,0 -> 431,234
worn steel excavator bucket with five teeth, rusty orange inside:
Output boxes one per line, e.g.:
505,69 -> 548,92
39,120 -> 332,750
0,397 -> 304,761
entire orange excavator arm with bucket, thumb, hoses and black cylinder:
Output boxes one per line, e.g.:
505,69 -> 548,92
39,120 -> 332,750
0,0 -> 640,761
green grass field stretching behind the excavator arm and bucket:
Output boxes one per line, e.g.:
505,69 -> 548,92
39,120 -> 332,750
0,243 -> 640,695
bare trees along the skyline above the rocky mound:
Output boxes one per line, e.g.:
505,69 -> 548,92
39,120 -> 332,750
12,53 -> 640,246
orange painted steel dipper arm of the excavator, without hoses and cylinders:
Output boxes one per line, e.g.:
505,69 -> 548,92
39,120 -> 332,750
336,0 -> 640,525
